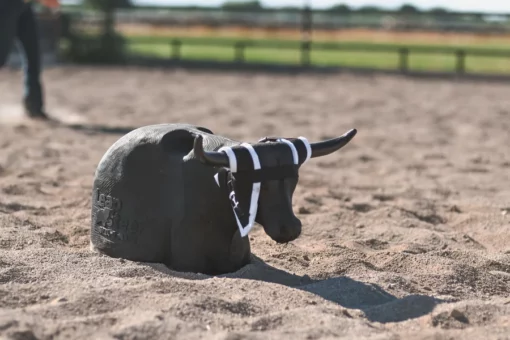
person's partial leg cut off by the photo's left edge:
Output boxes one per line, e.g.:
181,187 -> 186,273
0,0 -> 23,67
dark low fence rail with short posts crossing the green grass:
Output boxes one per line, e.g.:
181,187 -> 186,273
130,38 -> 510,74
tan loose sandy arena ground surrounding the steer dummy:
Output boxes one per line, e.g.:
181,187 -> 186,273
0,67 -> 510,339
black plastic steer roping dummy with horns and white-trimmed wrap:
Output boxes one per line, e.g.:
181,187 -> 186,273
91,124 -> 356,275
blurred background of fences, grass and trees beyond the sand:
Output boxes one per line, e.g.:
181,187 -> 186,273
6,0 -> 510,75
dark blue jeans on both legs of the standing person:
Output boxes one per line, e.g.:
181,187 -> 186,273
0,0 -> 43,111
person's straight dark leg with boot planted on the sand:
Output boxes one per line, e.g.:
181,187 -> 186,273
17,4 -> 46,118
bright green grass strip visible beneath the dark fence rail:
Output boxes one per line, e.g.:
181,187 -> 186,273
128,37 -> 510,74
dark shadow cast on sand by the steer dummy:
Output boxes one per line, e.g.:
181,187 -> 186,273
144,255 -> 446,323
